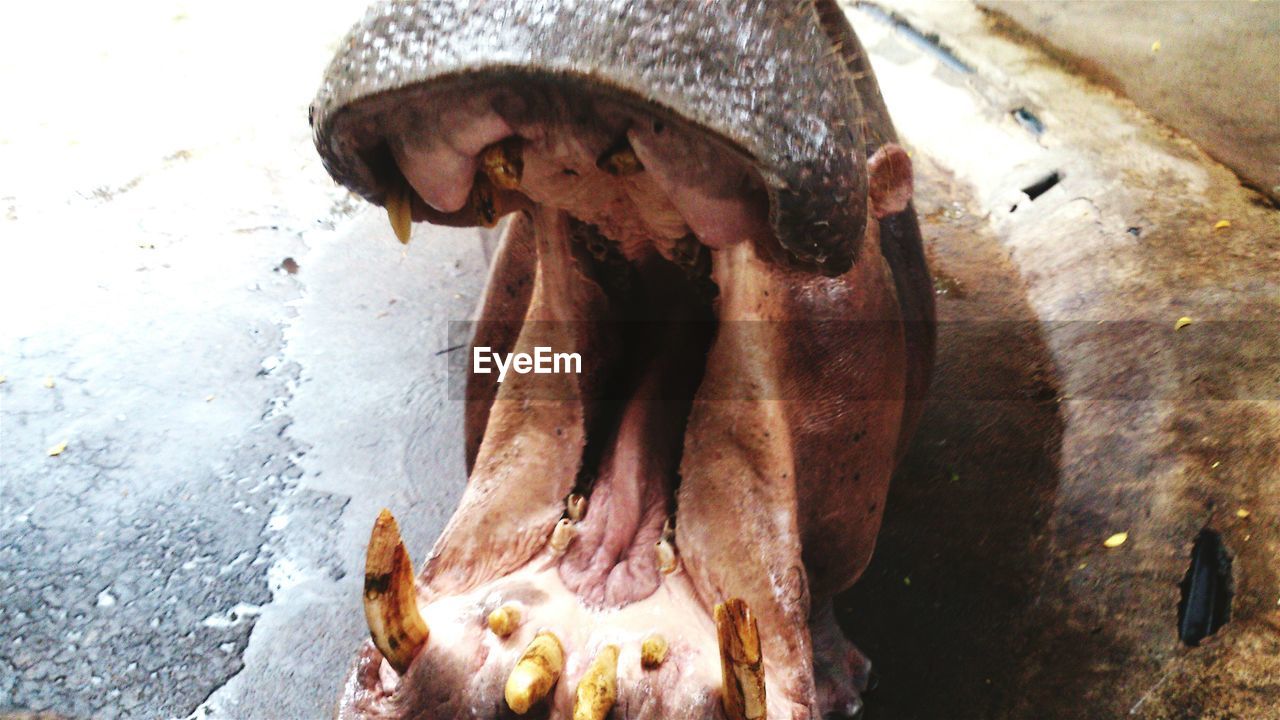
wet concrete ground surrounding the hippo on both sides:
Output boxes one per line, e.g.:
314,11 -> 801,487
0,1 -> 1280,719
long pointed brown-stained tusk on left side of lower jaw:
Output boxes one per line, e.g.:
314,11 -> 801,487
365,509 -> 430,675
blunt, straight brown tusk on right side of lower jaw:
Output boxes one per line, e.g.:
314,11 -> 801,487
716,598 -> 765,720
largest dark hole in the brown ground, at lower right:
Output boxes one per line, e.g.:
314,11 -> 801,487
1178,528 -> 1234,647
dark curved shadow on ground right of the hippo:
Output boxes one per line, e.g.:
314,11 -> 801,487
836,161 -> 1110,720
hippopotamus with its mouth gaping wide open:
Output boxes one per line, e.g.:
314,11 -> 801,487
311,0 -> 934,720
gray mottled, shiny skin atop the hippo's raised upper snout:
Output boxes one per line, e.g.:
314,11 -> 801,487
311,0 -> 867,275
